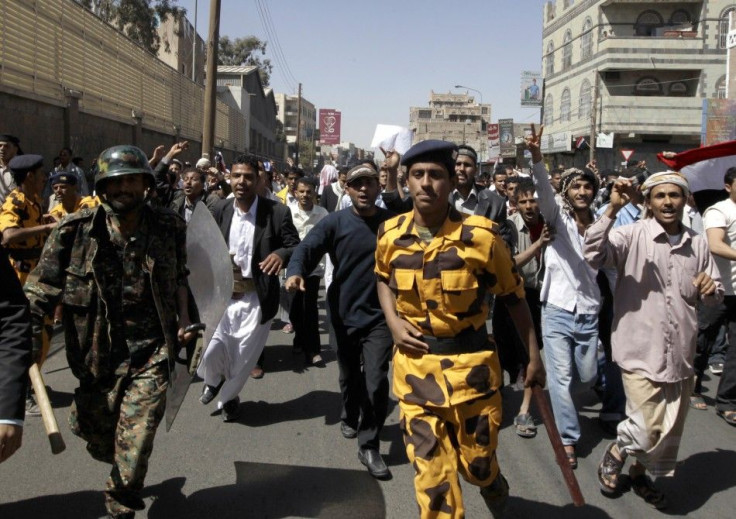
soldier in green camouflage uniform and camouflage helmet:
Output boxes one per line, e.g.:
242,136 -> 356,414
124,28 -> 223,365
25,146 -> 197,518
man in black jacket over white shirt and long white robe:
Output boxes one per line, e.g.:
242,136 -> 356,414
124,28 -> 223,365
197,155 -> 299,422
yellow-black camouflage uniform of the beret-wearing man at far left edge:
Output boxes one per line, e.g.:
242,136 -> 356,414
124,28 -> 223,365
0,188 -> 47,285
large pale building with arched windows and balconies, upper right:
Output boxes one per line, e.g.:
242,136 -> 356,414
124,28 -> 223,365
542,0 -> 736,167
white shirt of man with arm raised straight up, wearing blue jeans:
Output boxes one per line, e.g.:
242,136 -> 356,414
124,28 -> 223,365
532,162 -> 601,314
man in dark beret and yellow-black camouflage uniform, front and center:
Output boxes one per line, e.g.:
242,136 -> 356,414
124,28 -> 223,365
375,140 -> 545,518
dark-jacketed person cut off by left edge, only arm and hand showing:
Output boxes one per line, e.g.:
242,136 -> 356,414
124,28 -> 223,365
0,245 -> 31,463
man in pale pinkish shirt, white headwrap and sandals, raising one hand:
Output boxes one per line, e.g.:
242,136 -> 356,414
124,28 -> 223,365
583,171 -> 723,509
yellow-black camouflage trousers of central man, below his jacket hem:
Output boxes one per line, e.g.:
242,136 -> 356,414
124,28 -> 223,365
399,391 -> 501,519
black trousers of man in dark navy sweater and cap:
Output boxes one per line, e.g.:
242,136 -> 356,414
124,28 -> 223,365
333,321 -> 393,449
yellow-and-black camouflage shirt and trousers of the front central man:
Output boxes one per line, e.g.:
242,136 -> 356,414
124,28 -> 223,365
375,208 -> 524,518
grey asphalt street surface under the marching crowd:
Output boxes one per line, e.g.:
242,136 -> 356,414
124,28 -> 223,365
0,304 -> 736,519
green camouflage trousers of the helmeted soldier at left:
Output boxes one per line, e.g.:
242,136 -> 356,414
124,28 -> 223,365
69,361 -> 169,517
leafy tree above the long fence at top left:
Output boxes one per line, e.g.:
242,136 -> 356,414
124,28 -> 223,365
76,0 -> 186,54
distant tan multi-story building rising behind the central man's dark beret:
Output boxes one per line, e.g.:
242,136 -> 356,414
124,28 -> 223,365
409,91 -> 491,160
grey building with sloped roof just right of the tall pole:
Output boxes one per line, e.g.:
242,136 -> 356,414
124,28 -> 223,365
215,66 -> 283,161
